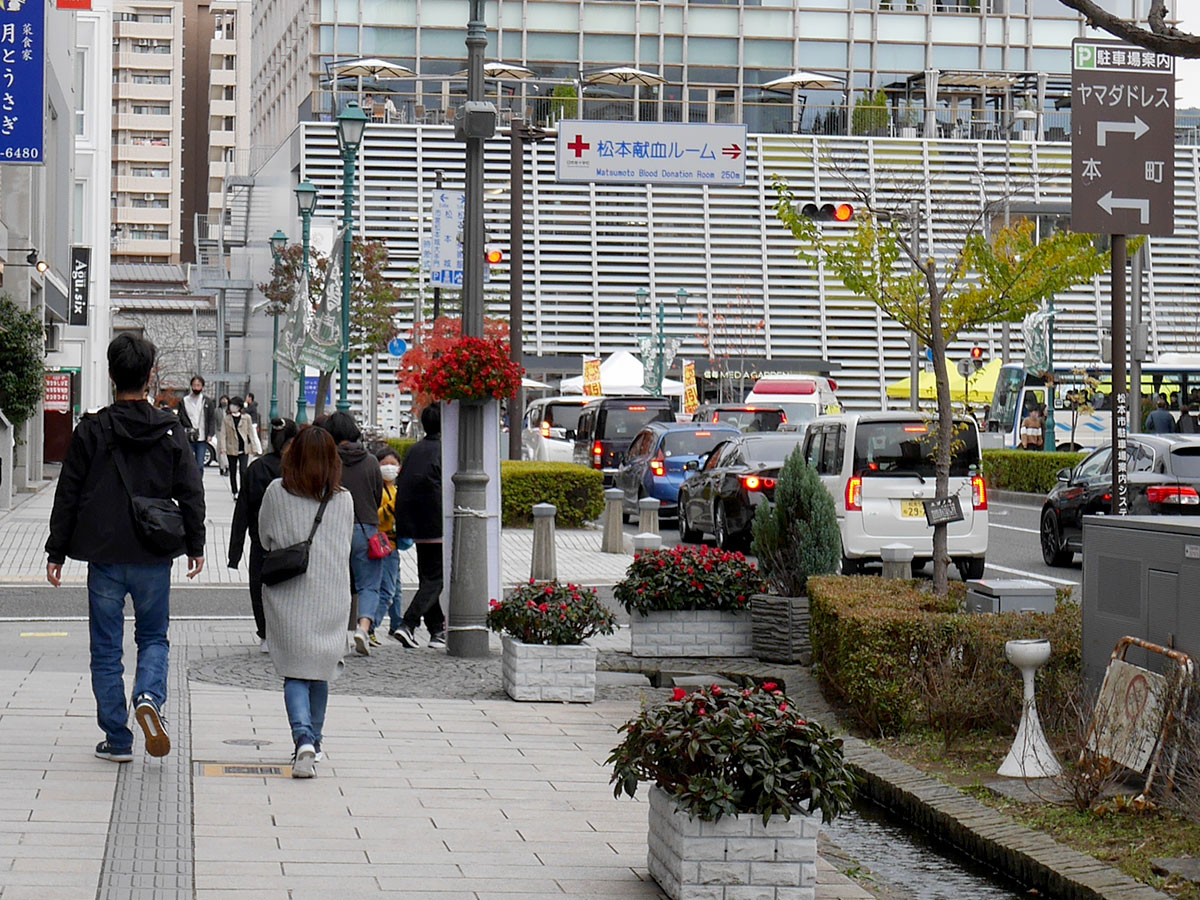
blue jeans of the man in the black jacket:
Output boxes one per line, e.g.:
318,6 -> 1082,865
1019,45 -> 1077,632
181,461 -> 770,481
88,563 -> 170,750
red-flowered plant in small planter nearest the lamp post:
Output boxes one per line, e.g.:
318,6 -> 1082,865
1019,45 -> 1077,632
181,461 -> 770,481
487,580 -> 616,644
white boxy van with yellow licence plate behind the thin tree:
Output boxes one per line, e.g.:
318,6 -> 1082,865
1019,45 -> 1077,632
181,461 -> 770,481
804,412 -> 988,580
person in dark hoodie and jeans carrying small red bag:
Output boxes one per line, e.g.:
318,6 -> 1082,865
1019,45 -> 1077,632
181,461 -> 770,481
323,410 -> 383,656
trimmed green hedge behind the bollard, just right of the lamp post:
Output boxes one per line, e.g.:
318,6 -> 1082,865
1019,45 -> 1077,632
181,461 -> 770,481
500,461 -> 604,528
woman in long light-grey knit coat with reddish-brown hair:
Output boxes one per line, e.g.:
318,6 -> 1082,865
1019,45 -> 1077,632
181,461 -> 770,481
258,427 -> 354,778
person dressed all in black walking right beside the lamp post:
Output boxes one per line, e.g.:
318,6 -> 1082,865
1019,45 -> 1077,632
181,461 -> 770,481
392,406 -> 446,650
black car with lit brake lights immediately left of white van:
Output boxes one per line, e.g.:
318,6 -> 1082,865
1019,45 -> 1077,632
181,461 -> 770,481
679,433 -> 804,550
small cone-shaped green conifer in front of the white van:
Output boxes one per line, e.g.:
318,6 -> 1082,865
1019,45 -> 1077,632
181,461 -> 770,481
750,446 -> 841,596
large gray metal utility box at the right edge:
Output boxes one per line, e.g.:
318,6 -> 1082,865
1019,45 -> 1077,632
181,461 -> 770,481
1084,516 -> 1200,689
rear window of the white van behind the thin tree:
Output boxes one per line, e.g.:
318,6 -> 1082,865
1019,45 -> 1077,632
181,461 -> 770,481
854,420 -> 979,478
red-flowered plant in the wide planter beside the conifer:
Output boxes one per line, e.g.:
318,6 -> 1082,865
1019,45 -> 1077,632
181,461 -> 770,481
613,545 -> 763,613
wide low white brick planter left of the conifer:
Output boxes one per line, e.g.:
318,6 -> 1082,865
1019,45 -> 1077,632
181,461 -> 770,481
629,610 -> 754,656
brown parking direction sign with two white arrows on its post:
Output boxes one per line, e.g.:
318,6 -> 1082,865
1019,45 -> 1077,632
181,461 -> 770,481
1070,37 -> 1175,516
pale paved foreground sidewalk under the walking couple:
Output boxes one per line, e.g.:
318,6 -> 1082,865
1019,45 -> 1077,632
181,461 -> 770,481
0,622 -> 868,900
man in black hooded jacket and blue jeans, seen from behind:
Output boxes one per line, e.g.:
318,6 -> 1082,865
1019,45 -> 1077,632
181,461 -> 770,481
46,332 -> 204,762
